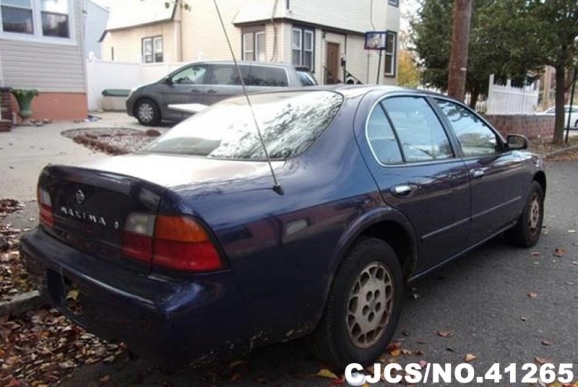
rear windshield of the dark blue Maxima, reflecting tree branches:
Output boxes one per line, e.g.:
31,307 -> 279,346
145,91 -> 343,160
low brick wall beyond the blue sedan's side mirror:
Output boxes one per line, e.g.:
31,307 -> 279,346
484,115 -> 554,138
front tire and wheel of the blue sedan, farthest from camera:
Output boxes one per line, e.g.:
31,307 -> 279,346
506,181 -> 544,247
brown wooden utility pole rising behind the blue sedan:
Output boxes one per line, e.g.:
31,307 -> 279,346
448,0 -> 473,101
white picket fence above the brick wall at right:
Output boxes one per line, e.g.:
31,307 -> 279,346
486,75 -> 540,114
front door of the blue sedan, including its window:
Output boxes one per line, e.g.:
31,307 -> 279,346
435,98 -> 529,244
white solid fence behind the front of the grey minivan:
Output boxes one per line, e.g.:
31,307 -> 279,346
86,58 -> 185,111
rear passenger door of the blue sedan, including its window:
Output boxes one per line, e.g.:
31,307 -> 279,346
366,96 -> 471,273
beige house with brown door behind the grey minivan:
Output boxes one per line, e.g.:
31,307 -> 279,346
102,0 -> 400,84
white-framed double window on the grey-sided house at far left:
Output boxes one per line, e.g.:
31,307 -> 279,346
0,0 -> 71,38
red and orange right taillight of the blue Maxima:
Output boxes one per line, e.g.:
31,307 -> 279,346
123,214 -> 223,272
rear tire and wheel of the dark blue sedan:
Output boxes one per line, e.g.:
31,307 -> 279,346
312,238 -> 403,368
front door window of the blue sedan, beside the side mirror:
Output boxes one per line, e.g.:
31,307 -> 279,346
436,99 -> 501,157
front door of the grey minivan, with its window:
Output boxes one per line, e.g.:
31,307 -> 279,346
159,64 -> 208,118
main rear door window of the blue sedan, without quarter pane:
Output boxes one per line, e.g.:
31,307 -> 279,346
382,97 -> 454,162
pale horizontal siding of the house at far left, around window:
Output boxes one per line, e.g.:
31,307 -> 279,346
0,0 -> 85,92
